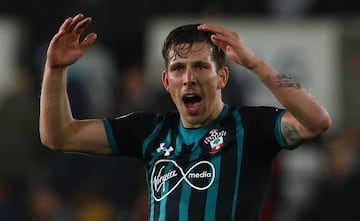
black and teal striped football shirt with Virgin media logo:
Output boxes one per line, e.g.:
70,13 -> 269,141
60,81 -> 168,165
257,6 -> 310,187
104,105 -> 288,221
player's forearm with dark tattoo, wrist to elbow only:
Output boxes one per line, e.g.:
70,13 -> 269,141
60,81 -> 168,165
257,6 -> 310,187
252,60 -> 330,135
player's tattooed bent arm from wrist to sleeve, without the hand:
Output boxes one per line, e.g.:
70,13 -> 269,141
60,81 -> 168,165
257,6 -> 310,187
252,60 -> 331,146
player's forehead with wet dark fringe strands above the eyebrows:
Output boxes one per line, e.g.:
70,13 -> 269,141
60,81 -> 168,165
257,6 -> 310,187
169,42 -> 213,62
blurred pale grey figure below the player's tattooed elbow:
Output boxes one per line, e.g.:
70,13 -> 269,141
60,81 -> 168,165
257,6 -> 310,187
270,143 -> 324,221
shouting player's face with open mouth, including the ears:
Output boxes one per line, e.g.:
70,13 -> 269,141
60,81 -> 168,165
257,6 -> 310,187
162,43 -> 229,128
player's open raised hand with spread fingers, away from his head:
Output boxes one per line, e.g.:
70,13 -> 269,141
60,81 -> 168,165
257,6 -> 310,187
46,14 -> 97,68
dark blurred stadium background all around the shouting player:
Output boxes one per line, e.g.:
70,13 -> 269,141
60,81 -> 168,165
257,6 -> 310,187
0,0 -> 360,221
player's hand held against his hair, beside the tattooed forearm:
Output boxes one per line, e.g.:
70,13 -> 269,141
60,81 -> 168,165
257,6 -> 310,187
198,24 -> 260,69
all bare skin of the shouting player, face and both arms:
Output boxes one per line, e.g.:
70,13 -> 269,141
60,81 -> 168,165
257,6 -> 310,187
39,14 -> 331,155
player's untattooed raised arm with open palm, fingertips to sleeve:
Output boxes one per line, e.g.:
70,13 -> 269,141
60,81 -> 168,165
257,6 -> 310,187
39,14 -> 110,154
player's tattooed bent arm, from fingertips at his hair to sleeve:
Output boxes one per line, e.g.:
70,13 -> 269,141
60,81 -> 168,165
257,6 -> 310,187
199,25 -> 331,146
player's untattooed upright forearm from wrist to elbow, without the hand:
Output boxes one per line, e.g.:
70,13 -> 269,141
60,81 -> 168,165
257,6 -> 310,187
40,66 -> 73,147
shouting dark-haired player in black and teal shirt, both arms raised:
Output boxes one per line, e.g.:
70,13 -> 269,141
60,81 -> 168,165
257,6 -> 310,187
40,14 -> 331,221
